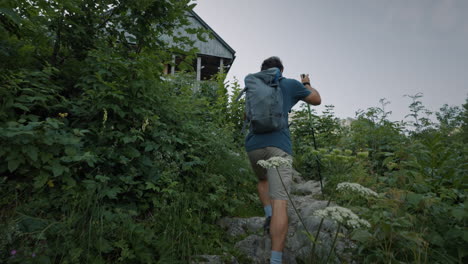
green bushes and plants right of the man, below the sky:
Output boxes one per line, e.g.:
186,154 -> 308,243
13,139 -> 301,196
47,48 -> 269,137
293,94 -> 468,263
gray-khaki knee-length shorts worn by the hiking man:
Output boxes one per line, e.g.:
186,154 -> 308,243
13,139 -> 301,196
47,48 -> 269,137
247,147 -> 293,200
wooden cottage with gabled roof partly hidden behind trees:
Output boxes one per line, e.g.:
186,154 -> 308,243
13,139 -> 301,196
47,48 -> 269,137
165,11 -> 236,81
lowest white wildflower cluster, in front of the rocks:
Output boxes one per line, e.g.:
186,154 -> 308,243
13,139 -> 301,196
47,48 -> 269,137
314,206 -> 370,228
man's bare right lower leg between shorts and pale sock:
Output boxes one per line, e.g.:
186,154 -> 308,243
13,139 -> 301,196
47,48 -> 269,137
270,200 -> 288,252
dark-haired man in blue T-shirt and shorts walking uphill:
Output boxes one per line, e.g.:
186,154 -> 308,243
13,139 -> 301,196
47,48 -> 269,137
245,57 -> 321,264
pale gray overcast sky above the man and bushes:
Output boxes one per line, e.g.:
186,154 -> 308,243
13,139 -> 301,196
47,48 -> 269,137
195,0 -> 468,121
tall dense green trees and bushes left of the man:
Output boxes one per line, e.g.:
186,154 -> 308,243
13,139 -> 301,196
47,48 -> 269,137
0,0 -> 254,263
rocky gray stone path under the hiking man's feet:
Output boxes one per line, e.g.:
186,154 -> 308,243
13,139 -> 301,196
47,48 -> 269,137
195,172 -> 344,264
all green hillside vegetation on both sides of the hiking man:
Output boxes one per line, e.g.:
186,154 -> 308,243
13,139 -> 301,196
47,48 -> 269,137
0,0 -> 468,263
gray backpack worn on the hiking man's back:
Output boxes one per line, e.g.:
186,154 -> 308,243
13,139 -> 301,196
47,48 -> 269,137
237,68 -> 287,134
